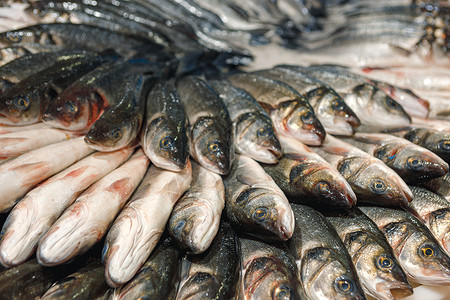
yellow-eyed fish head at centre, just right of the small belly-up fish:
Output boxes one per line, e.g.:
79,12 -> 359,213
235,188 -> 295,241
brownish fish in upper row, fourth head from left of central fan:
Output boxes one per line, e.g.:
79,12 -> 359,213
228,73 -> 326,146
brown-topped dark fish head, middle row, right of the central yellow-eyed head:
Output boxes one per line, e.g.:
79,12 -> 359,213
286,161 -> 356,207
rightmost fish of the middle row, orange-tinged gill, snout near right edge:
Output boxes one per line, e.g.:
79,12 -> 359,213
341,133 -> 449,184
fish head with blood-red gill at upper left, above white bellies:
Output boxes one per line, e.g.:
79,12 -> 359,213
43,86 -> 106,131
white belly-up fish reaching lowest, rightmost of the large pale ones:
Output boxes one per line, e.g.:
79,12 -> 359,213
102,162 -> 192,287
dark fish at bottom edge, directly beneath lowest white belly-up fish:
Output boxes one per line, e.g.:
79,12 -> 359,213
113,238 -> 180,300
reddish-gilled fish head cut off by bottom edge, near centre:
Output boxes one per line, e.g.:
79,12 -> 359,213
243,256 -> 299,300
